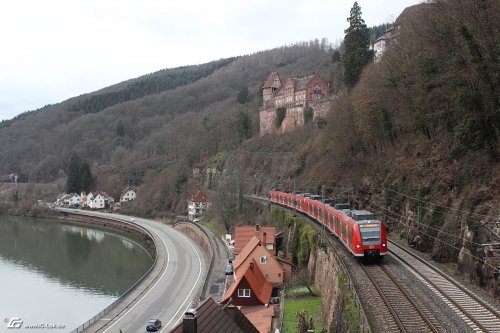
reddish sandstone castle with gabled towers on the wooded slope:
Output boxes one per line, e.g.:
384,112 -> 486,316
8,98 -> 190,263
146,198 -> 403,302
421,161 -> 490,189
259,72 -> 330,136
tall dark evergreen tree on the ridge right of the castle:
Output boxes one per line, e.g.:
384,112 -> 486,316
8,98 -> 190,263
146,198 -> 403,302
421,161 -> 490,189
342,2 -> 374,88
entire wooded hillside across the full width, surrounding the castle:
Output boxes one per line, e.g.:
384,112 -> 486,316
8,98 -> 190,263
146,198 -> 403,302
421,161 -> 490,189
0,0 -> 500,296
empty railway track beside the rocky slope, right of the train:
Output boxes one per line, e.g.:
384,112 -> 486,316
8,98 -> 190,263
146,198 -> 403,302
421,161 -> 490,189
390,242 -> 500,332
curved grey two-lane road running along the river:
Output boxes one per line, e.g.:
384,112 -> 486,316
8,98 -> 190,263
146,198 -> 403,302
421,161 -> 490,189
59,209 -> 207,333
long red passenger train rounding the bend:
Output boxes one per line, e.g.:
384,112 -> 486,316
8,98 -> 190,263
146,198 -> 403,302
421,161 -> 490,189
268,190 -> 387,259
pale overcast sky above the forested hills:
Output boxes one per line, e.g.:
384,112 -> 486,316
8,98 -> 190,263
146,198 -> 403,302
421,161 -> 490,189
0,0 -> 422,120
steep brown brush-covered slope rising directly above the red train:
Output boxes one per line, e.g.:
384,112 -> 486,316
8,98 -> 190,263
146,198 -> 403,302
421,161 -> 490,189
228,1 -> 500,297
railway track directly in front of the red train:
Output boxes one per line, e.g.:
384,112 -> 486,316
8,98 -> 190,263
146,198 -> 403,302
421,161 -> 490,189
360,264 -> 443,333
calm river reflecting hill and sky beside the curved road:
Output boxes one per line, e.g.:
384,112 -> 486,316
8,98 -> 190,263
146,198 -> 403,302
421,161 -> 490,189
0,215 -> 152,333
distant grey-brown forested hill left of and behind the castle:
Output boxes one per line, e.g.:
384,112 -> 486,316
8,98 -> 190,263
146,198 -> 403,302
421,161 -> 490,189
0,42 -> 331,189
